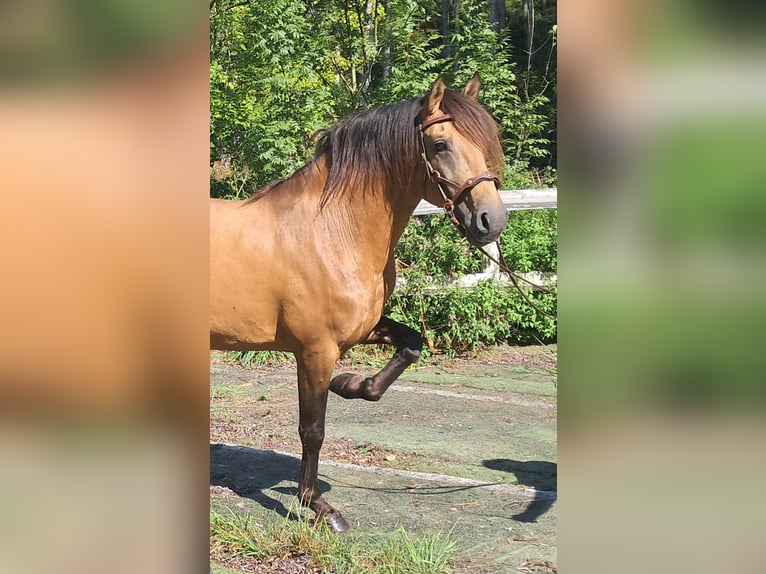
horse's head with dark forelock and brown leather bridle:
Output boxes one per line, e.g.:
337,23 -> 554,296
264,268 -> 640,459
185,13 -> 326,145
418,74 -> 508,246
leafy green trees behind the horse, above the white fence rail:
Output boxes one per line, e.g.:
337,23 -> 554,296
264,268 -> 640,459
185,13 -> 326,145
210,0 -> 555,197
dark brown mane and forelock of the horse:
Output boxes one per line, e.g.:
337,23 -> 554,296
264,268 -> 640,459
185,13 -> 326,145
248,90 -> 503,208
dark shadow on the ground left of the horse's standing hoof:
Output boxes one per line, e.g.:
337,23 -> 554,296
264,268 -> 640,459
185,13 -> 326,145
210,444 -> 330,518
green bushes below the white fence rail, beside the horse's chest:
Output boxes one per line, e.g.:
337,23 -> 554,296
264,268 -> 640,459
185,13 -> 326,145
385,210 -> 557,353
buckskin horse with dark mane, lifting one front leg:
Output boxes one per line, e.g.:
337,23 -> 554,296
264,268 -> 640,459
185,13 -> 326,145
210,74 -> 508,532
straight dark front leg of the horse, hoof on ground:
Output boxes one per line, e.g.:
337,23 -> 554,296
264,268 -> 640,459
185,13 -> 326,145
297,352 -> 349,532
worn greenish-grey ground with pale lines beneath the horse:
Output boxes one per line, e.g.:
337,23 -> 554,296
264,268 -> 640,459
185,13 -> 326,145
210,346 -> 557,574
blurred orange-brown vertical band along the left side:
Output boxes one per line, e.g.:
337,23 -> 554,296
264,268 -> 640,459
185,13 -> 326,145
0,0 -> 209,573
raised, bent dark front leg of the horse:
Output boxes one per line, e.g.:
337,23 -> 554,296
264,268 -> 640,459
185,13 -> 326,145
330,317 -> 423,401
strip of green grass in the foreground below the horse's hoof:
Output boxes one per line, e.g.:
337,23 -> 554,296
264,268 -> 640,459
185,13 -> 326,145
210,507 -> 455,574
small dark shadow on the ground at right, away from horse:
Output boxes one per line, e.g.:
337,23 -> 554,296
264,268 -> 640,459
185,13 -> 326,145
483,458 -> 558,522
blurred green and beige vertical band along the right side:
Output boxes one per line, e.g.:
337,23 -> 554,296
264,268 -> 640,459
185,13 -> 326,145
558,0 -> 766,573
